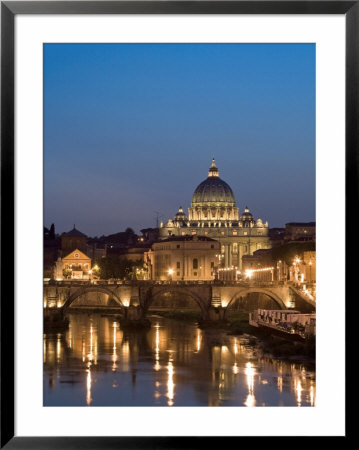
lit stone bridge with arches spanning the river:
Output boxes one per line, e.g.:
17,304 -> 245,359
44,280 -> 315,320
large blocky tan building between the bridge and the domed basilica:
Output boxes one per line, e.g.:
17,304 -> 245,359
145,235 -> 221,281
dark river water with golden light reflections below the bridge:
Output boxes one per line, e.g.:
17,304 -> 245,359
44,313 -> 315,407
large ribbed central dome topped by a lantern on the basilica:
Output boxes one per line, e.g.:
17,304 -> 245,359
192,158 -> 236,207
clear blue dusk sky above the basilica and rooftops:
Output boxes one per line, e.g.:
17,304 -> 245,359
44,44 -> 315,236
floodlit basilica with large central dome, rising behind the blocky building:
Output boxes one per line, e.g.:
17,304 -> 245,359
159,159 -> 271,270
